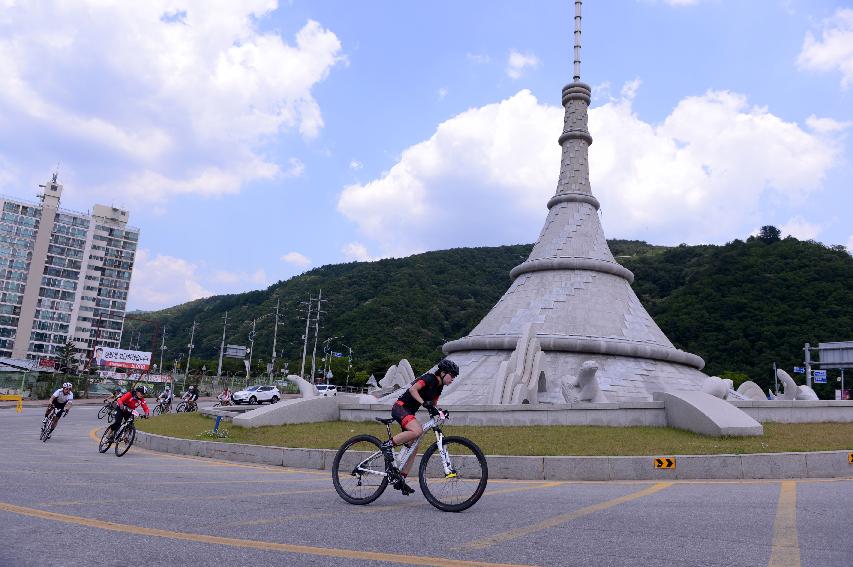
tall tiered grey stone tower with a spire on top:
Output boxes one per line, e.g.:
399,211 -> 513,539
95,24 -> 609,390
442,0 -> 706,404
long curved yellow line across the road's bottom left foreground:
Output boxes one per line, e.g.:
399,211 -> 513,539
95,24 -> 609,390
0,502 -> 532,567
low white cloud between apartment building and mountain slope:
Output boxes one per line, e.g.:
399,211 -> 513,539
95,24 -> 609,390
128,248 -> 213,309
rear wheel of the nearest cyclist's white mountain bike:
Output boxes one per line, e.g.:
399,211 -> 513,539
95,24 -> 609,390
332,435 -> 388,505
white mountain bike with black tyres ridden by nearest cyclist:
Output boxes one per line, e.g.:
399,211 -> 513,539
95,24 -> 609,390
332,411 -> 489,512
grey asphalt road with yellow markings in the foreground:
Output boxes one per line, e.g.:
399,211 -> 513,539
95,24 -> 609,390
0,406 -> 853,567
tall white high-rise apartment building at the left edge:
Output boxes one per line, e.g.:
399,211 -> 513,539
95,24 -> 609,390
0,175 -> 139,360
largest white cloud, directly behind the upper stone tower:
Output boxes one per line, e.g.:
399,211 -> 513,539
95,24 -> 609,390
338,83 -> 838,256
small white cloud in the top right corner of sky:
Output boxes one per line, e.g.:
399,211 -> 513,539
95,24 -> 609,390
797,8 -> 853,88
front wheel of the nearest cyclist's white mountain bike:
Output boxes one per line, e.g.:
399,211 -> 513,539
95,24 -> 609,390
418,437 -> 489,512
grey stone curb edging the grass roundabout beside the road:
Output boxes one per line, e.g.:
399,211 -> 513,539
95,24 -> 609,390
136,431 -> 853,480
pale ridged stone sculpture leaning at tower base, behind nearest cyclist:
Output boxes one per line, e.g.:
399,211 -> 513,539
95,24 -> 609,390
490,324 -> 545,405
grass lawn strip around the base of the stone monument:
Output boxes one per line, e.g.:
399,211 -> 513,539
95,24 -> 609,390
136,413 -> 853,456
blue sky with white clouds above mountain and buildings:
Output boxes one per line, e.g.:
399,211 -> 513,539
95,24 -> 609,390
0,0 -> 853,309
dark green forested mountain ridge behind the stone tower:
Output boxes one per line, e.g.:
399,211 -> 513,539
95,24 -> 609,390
123,235 -> 853,397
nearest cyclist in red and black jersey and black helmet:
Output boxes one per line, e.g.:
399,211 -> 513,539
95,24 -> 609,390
382,358 -> 459,495
